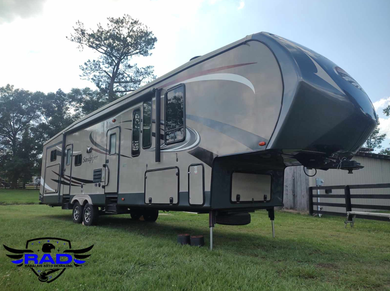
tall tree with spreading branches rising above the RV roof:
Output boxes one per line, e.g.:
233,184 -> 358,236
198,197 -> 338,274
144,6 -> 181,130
67,14 -> 157,102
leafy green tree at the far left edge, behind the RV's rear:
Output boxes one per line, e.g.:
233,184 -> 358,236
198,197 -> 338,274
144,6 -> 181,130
0,85 -> 42,188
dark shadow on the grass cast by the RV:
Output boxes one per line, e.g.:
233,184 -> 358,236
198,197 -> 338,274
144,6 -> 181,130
45,214 -> 361,268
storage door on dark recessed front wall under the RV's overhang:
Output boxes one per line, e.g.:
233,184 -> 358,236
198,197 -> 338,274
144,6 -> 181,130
231,172 -> 272,203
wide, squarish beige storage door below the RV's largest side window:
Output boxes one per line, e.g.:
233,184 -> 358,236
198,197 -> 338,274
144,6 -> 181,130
145,167 -> 179,204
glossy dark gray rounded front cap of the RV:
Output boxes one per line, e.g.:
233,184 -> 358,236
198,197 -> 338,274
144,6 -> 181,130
252,33 -> 377,163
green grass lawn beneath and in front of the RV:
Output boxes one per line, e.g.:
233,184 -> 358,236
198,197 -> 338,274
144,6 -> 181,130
0,193 -> 390,291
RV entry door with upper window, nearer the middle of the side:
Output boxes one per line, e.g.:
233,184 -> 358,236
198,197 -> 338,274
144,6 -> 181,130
104,127 -> 121,194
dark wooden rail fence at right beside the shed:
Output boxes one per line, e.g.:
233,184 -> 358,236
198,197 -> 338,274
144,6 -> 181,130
309,183 -> 390,221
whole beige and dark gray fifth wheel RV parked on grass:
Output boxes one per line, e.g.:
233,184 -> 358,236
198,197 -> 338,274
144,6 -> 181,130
40,33 -> 377,249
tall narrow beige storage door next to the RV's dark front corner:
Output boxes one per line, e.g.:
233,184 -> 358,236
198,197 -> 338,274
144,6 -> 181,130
188,164 -> 204,205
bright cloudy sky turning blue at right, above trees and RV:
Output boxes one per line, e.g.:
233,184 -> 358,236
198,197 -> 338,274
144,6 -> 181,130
0,0 -> 390,147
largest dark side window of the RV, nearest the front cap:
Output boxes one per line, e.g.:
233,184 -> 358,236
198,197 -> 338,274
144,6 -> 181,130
165,85 -> 185,144
